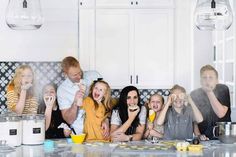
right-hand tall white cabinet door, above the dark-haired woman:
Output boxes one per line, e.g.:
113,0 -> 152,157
133,9 -> 174,89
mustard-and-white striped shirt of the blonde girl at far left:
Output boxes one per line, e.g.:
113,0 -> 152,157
6,86 -> 38,114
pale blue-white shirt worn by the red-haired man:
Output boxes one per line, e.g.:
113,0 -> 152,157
57,71 -> 102,134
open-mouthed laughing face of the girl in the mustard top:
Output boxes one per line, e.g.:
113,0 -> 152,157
92,82 -> 106,103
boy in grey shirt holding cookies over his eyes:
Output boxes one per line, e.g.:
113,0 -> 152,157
157,85 -> 203,140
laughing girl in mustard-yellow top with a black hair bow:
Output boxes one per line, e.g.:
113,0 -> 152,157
78,80 -> 112,142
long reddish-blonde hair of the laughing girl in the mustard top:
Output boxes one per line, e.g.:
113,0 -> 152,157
89,80 -> 112,112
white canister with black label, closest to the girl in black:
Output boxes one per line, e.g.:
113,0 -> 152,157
22,114 -> 45,145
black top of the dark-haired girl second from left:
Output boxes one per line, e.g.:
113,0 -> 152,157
39,105 -> 69,139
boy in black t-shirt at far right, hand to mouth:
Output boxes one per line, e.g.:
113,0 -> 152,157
191,65 -> 231,140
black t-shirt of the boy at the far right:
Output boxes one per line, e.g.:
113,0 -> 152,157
191,84 -> 231,139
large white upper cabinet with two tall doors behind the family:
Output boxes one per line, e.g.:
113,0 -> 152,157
79,0 -> 174,89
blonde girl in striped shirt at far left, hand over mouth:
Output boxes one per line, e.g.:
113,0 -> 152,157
6,65 -> 38,114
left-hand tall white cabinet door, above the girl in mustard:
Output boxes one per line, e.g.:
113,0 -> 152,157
94,9 -> 131,89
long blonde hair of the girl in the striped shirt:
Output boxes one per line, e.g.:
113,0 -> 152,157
8,65 -> 34,97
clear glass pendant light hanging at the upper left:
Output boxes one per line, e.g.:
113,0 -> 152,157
6,0 -> 43,30
